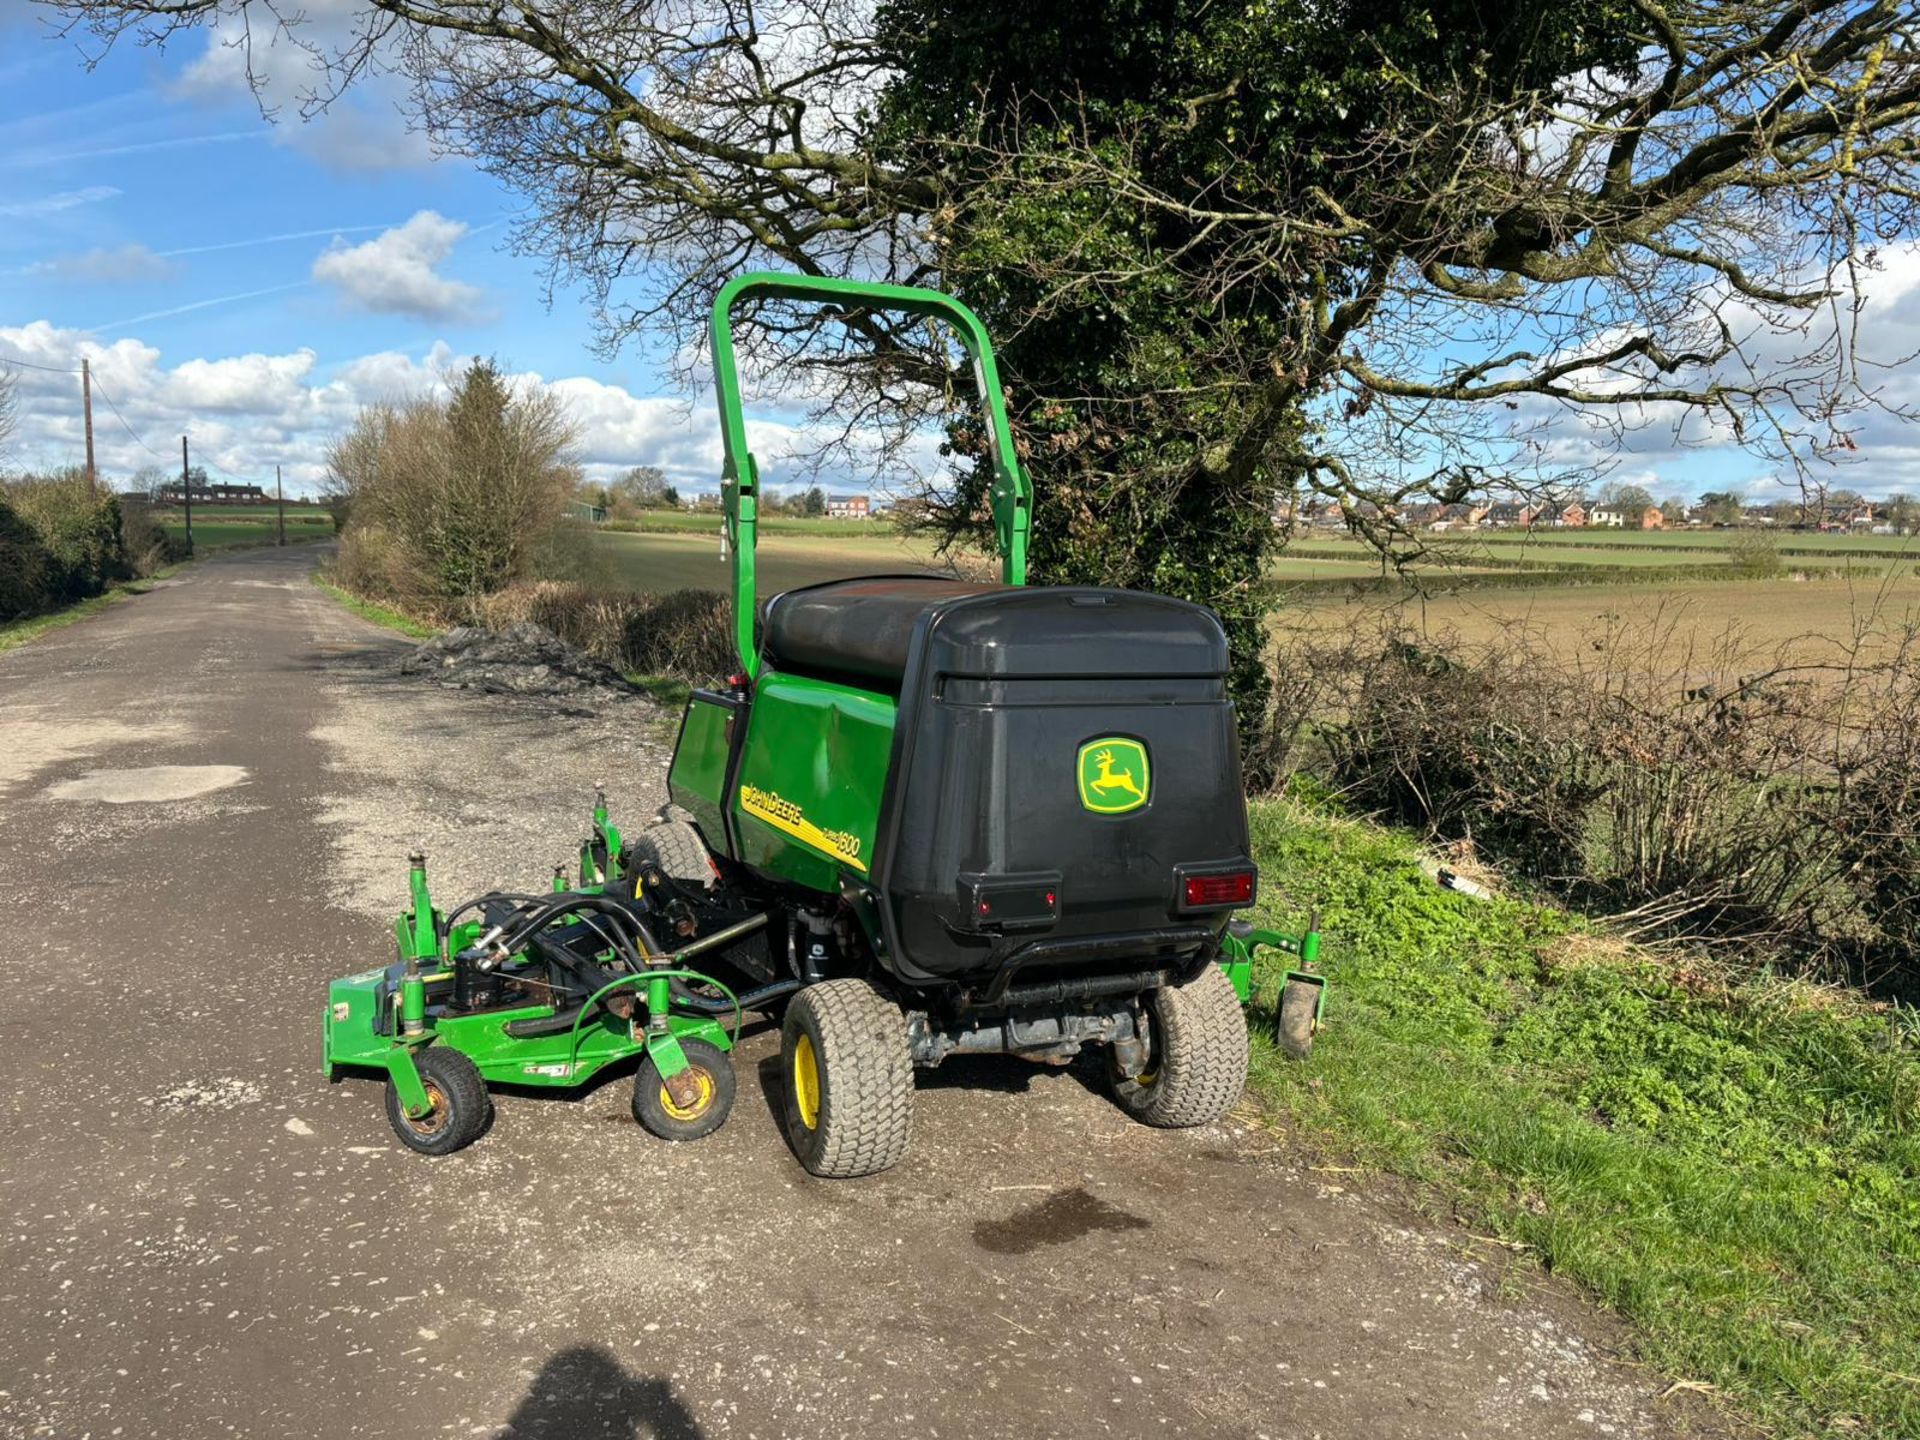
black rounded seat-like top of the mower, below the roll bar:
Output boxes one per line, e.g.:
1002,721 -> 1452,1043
760,576 -> 1006,689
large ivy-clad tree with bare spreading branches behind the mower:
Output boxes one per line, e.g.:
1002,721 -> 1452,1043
50,0 -> 1920,708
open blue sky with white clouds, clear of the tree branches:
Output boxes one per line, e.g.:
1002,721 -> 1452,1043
0,0 -> 1920,497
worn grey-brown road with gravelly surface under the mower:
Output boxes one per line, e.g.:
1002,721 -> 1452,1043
0,551 -> 1712,1440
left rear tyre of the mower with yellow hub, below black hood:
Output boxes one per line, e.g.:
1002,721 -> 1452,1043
780,979 -> 914,1179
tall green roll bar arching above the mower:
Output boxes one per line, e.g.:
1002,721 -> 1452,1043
712,273 -> 1033,678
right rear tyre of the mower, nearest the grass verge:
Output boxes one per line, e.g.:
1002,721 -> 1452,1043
1110,964 -> 1246,1129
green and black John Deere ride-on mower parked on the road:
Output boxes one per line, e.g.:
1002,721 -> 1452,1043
326,275 -> 1325,1177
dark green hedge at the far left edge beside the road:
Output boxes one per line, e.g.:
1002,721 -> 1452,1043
0,470 -> 132,618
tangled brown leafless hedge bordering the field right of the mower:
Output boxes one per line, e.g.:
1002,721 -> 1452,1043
1254,620 -> 1920,991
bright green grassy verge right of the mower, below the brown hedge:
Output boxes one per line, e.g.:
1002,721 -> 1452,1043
1252,803 -> 1920,1436
